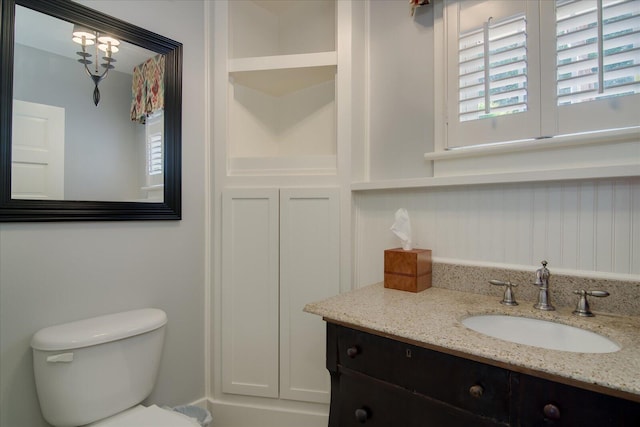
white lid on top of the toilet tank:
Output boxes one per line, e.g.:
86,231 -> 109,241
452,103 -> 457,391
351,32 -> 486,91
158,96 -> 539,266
31,308 -> 167,351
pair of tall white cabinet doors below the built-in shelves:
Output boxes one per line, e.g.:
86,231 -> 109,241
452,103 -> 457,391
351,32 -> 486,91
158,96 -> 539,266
222,188 -> 340,403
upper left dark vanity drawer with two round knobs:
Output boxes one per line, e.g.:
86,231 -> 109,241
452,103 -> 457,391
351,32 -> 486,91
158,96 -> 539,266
337,327 -> 510,423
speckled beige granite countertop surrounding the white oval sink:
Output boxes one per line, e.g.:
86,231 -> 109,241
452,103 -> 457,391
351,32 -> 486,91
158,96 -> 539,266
304,283 -> 640,402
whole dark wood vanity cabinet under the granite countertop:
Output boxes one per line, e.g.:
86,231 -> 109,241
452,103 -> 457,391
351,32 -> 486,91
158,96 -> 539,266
327,323 -> 640,427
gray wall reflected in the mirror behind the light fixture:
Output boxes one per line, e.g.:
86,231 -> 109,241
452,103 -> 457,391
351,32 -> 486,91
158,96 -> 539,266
13,45 -> 145,200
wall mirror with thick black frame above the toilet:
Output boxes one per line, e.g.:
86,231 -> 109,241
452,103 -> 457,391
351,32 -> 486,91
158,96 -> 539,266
0,0 -> 182,222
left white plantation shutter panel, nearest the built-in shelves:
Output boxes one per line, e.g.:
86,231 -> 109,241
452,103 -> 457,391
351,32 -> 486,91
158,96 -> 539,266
445,0 -> 540,149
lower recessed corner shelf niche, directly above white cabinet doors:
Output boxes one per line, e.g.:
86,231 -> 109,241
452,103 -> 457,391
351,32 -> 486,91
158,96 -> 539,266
228,77 -> 336,174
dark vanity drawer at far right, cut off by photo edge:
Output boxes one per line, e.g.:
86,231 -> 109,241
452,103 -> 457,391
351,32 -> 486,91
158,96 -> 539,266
513,374 -> 640,427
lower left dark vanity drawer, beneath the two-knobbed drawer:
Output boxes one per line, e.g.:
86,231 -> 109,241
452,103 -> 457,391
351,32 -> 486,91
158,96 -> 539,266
338,372 -> 508,427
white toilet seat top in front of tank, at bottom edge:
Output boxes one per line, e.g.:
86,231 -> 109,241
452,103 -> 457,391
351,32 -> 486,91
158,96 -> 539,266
87,405 -> 200,427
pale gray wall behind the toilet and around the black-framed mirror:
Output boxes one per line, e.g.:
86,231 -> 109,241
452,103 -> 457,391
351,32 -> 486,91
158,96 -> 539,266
0,0 -> 206,427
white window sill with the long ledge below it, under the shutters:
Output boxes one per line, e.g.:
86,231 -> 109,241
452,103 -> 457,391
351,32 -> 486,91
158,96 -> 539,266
351,127 -> 640,191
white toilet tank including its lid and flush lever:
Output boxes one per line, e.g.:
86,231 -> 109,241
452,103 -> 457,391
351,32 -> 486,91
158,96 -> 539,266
31,308 -> 167,427
